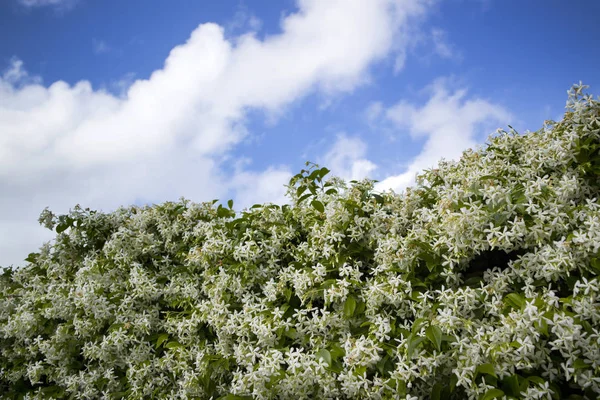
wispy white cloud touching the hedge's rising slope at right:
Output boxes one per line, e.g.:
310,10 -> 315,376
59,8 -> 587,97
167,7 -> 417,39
376,79 -> 512,192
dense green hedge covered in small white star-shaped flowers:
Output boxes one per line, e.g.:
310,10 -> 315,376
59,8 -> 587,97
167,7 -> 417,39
0,85 -> 600,399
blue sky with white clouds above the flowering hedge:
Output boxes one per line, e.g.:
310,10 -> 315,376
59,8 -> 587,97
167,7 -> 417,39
0,0 -> 600,266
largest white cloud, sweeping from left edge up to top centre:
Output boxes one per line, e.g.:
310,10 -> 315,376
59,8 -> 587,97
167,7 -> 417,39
0,0 -> 429,265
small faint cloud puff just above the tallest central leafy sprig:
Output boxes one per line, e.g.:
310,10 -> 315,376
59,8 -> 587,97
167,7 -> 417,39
319,134 -> 377,180
